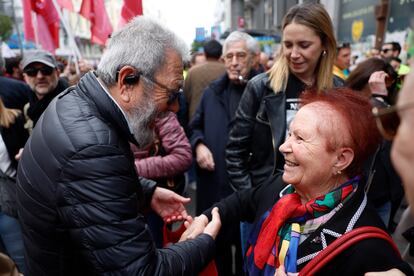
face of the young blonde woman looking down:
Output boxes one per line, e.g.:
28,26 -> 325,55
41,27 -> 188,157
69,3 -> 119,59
282,22 -> 324,79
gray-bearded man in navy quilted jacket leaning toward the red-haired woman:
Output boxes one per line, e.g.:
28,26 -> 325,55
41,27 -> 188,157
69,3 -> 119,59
17,16 -> 220,275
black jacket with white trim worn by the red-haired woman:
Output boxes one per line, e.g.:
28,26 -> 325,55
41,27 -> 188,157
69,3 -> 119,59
204,175 -> 414,275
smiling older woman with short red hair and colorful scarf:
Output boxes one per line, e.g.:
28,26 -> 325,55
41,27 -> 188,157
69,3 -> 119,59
184,88 -> 413,275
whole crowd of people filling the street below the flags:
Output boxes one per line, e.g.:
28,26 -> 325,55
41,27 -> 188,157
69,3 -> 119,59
0,3 -> 414,276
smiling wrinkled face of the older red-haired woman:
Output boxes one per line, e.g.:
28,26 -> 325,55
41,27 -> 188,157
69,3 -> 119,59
279,103 -> 341,194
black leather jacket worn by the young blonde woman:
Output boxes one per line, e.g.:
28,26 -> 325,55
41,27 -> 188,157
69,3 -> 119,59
226,73 -> 343,191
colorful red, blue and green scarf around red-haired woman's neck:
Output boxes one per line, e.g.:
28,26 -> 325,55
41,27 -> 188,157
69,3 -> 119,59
246,177 -> 359,275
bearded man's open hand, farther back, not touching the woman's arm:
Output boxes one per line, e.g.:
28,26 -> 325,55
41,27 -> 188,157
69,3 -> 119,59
151,187 -> 191,223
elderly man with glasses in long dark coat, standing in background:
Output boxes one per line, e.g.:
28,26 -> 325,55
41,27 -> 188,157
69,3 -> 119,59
190,31 -> 257,275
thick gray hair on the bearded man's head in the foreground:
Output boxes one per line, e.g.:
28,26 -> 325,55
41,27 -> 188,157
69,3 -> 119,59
97,16 -> 190,86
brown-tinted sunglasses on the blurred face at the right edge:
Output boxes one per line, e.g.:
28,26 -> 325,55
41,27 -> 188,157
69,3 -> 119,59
372,102 -> 414,140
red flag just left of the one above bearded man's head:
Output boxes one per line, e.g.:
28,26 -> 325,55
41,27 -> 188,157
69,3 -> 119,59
79,0 -> 112,45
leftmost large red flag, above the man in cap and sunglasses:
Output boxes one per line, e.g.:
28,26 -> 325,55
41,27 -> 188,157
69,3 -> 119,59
23,0 -> 59,53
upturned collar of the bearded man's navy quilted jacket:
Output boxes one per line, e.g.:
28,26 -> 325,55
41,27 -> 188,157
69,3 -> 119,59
78,72 -> 138,145
